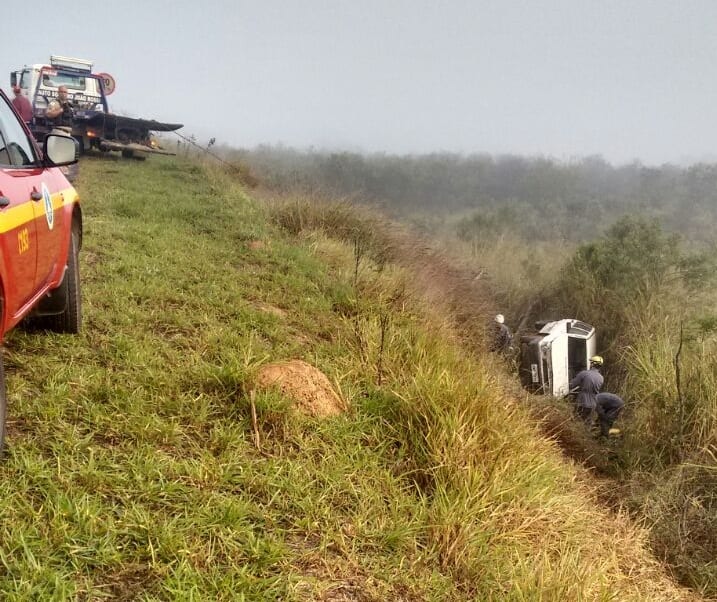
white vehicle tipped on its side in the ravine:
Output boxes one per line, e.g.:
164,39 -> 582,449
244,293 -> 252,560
520,319 -> 596,397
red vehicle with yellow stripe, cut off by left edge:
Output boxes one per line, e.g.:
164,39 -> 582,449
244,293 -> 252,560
0,84 -> 82,449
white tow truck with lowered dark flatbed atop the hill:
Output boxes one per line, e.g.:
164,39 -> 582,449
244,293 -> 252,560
10,55 -> 182,157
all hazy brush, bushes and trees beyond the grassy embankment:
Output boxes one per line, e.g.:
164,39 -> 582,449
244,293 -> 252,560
228,147 -> 717,597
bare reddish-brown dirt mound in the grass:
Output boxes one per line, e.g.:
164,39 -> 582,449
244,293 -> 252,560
255,360 -> 347,417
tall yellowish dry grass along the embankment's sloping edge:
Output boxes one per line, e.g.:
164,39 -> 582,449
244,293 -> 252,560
272,196 -> 694,600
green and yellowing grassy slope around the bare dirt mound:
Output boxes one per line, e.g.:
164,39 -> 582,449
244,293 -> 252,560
0,159 -> 693,601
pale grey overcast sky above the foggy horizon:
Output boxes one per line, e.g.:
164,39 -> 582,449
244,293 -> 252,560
0,0 -> 717,164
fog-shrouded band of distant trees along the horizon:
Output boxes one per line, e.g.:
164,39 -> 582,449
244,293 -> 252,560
231,146 -> 717,241
